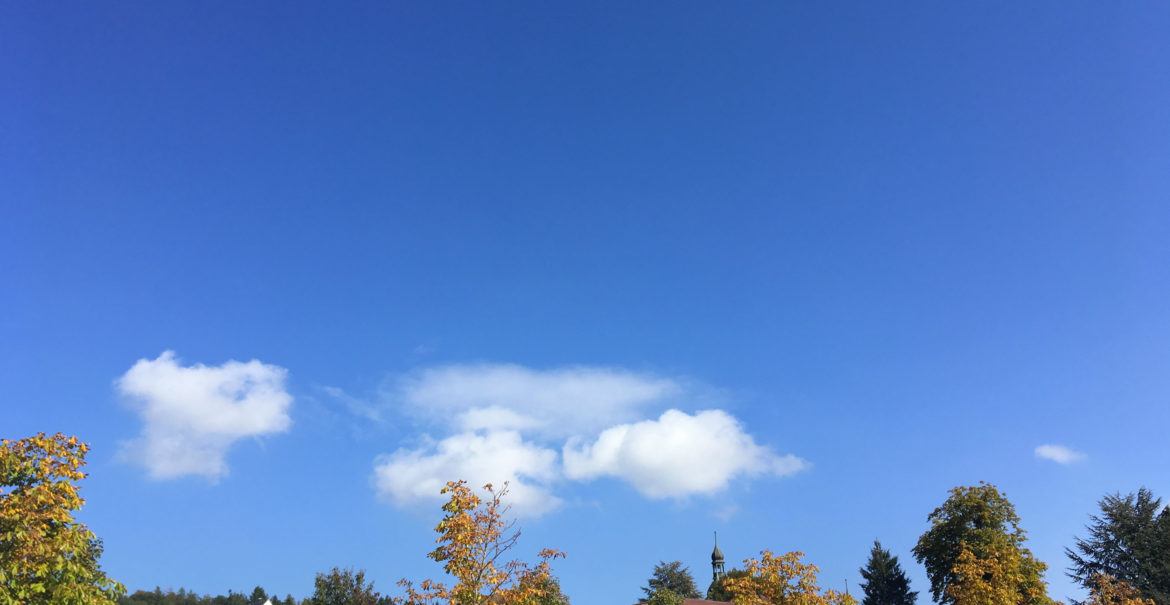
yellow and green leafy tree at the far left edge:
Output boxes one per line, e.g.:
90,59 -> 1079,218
0,433 -> 126,605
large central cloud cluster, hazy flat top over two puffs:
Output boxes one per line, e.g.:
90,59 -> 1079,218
373,364 -> 808,516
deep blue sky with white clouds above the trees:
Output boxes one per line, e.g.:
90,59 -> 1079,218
0,2 -> 1170,605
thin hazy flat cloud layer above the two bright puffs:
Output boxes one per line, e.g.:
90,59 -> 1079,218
391,364 -> 683,436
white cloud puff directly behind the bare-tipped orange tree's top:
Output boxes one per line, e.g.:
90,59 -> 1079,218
373,431 -> 560,516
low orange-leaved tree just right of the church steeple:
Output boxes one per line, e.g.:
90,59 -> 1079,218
724,550 -> 858,605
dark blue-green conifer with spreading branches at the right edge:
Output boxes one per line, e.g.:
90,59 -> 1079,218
1065,487 -> 1170,605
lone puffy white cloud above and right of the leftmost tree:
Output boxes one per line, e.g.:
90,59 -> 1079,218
115,351 -> 293,479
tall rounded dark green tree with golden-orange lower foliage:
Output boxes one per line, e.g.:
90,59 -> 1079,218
914,483 -> 1052,605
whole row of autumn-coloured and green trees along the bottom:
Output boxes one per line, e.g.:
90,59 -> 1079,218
0,433 -> 1170,605
